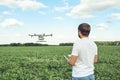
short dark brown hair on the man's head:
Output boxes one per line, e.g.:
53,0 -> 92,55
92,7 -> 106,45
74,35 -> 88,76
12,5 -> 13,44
78,23 -> 90,36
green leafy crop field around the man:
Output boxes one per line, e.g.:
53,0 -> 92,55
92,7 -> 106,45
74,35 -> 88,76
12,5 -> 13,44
0,46 -> 120,80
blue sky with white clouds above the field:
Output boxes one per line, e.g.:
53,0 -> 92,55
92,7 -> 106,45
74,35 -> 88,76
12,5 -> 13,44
0,0 -> 120,44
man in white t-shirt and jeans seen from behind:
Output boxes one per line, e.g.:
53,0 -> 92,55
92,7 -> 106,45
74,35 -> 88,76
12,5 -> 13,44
68,23 -> 98,80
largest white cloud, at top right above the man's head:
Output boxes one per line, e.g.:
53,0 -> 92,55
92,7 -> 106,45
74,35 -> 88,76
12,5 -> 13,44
66,0 -> 120,18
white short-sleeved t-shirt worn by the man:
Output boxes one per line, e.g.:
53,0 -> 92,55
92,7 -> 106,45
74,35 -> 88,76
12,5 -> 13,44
71,38 -> 97,77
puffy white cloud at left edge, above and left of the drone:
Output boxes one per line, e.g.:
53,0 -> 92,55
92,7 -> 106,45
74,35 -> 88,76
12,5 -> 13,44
0,18 -> 23,27
